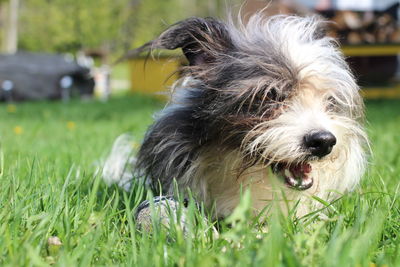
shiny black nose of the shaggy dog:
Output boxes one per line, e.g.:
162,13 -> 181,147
304,131 -> 336,158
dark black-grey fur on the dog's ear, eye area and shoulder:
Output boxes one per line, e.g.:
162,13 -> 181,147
137,18 -> 298,193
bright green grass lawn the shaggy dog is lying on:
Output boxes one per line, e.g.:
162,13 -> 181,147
0,96 -> 400,266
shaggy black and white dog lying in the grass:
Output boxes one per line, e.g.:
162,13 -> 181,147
104,14 -> 368,221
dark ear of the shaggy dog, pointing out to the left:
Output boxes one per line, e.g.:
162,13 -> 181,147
128,18 -> 233,66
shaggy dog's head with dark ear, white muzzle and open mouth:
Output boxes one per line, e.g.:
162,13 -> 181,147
139,15 -> 366,195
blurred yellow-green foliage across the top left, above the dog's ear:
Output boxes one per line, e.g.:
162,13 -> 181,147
19,0 -> 238,57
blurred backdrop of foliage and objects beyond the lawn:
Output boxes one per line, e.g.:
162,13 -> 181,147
0,0 -> 400,102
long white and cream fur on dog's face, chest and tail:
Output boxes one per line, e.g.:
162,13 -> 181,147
103,15 -> 368,220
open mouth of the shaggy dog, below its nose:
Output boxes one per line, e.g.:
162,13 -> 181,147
272,163 -> 314,190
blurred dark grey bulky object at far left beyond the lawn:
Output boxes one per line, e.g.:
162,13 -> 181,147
0,52 -> 94,101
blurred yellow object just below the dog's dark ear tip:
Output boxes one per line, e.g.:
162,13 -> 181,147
129,56 -> 184,99
